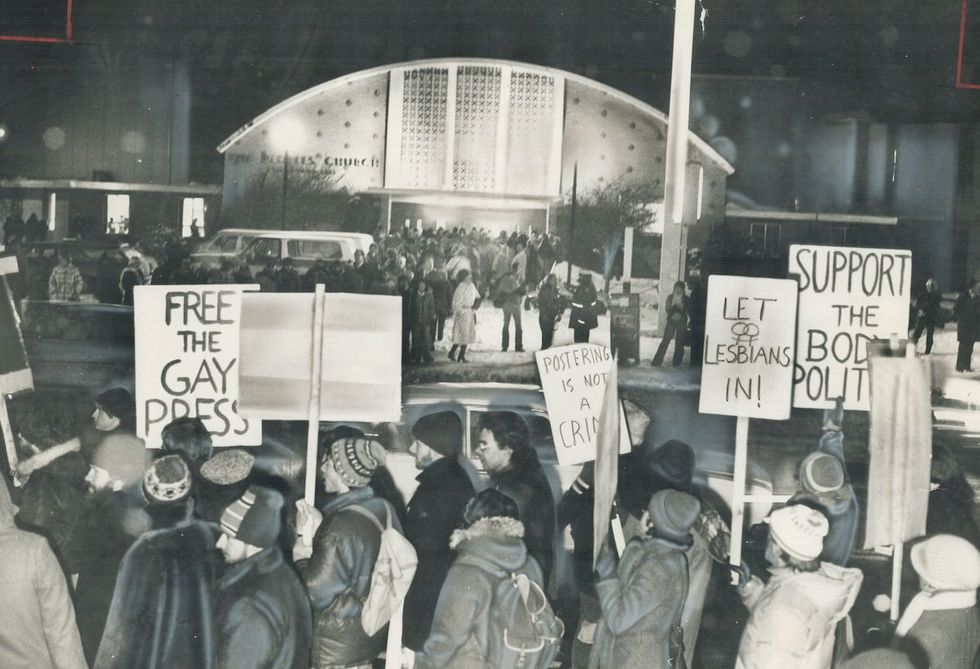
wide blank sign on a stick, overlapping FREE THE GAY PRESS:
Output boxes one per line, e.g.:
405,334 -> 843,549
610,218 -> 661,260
239,293 -> 402,422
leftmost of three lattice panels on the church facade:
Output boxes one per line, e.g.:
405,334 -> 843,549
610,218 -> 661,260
399,68 -> 449,188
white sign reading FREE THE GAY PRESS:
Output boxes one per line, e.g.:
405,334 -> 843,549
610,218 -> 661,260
133,285 -> 262,448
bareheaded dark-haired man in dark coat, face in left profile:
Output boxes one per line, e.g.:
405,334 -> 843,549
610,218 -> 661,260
476,411 -> 555,583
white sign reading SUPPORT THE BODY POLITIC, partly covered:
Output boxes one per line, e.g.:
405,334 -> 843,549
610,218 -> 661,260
788,244 -> 912,411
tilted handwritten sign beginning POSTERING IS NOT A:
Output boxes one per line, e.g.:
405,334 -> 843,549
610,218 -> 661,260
535,344 -> 630,465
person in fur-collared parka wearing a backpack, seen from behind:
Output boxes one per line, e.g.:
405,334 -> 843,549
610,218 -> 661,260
415,490 -> 561,669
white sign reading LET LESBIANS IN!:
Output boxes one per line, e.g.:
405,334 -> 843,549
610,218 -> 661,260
698,275 -> 798,420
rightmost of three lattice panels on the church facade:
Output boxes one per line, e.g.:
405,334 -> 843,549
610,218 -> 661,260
507,70 -> 556,194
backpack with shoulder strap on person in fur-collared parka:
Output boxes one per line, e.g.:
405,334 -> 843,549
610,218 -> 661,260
457,555 -> 565,669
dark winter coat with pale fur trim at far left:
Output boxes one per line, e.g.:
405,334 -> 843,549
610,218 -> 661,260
17,440 -> 93,574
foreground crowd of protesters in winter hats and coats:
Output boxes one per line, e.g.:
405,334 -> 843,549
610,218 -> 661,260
0,388 -> 980,669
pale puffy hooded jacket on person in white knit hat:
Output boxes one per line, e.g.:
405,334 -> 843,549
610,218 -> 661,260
735,562 -> 863,669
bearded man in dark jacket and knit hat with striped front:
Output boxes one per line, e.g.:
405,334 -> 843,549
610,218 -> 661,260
214,486 -> 313,669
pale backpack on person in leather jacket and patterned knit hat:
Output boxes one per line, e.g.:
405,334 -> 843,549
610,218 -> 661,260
348,502 -> 418,636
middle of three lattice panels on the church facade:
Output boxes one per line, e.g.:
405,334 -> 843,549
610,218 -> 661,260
453,66 -> 501,192
